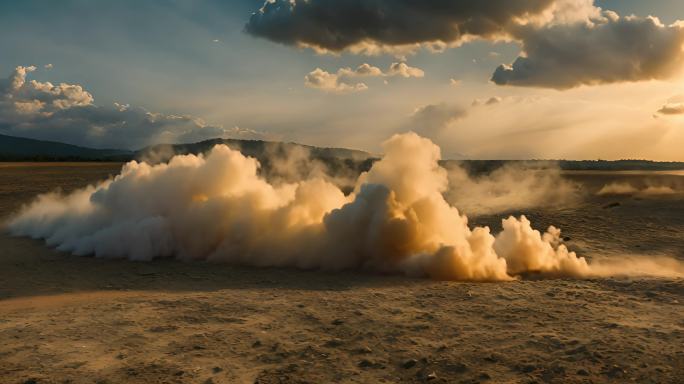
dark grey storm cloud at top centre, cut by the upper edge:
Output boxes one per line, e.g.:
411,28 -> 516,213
246,0 -> 554,51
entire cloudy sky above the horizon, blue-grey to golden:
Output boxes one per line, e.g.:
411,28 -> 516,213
0,0 -> 684,161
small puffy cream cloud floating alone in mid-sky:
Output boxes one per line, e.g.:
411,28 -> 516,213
304,62 -> 425,93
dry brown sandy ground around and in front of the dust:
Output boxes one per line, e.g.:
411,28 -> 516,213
0,164 -> 684,384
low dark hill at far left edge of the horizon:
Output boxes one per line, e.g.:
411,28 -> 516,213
0,135 -> 133,161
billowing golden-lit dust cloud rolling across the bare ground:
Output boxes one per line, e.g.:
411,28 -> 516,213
8,133 -> 684,281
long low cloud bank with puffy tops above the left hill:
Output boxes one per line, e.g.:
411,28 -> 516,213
0,66 -> 263,149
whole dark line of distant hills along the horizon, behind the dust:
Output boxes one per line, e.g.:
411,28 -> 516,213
0,135 -> 684,175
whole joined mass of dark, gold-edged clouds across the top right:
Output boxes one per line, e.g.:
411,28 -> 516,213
246,0 -> 684,89
